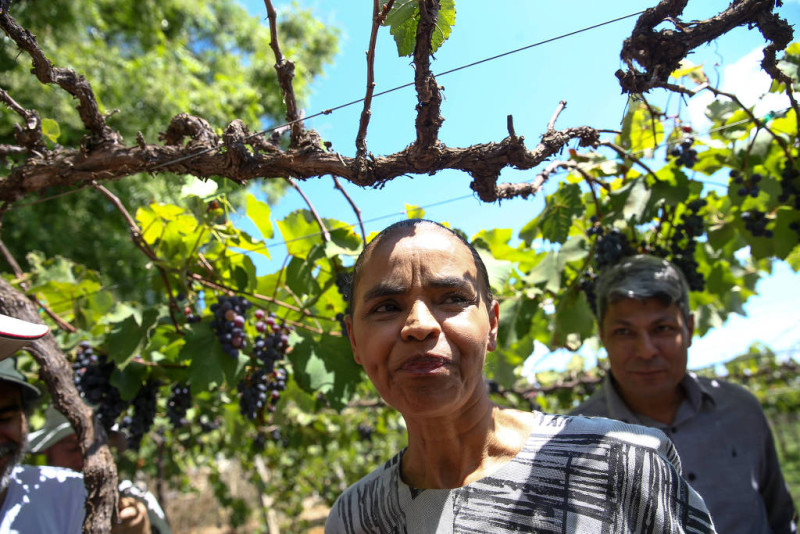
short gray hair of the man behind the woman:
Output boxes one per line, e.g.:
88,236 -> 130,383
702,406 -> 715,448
595,254 -> 691,328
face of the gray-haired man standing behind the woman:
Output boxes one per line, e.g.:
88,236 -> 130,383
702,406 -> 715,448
600,299 -> 694,411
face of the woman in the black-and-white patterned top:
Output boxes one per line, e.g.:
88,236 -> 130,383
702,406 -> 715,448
346,225 -> 498,418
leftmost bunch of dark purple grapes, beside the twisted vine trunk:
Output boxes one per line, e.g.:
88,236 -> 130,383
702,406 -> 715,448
72,341 -> 127,432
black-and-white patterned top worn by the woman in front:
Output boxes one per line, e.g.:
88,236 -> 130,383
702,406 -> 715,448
325,412 -> 715,534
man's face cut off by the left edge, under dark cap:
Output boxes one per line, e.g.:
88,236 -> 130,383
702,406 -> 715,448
0,381 -> 28,492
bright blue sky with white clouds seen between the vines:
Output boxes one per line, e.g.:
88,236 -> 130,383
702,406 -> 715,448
238,0 -> 800,370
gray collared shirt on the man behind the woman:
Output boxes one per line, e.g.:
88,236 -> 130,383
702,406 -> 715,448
572,372 -> 797,534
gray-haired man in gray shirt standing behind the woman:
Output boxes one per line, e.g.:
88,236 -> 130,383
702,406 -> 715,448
572,255 -> 797,534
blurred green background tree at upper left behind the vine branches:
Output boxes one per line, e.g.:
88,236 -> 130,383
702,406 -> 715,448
0,0 -> 337,298
